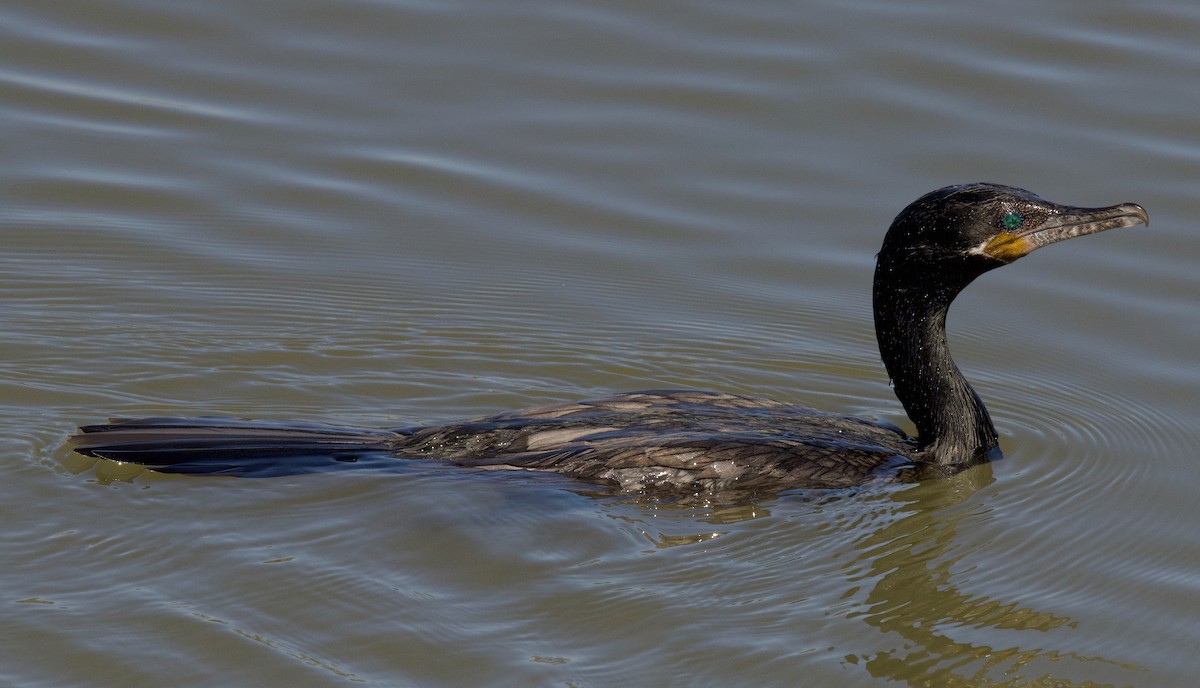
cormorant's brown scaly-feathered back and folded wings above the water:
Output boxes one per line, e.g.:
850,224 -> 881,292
394,390 -> 914,492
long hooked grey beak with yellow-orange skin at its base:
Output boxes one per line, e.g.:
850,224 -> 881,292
978,203 -> 1150,263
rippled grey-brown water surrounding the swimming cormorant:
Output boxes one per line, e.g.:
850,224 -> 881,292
0,0 -> 1200,687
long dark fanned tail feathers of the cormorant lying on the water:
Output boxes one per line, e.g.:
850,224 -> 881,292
71,418 -> 400,477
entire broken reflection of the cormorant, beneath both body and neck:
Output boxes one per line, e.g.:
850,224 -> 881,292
624,465 -> 1145,688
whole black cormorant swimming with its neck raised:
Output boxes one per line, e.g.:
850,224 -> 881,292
72,184 -> 1148,492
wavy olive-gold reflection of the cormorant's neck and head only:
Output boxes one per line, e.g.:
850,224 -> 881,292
845,465 -> 1136,688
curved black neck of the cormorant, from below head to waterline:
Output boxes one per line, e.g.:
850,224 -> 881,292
874,260 -> 996,465
